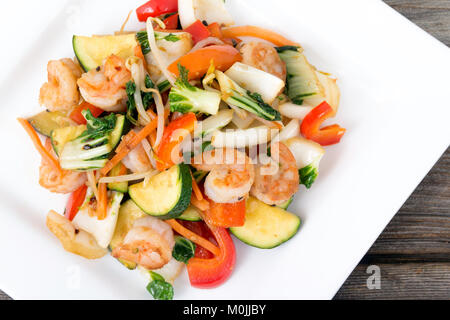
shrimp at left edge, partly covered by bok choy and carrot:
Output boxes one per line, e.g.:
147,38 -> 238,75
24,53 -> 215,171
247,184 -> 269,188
39,139 -> 87,193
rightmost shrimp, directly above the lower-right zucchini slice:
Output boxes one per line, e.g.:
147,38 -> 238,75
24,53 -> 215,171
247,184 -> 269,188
250,142 -> 300,205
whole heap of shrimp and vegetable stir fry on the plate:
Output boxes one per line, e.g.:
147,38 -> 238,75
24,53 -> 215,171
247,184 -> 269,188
18,0 -> 345,300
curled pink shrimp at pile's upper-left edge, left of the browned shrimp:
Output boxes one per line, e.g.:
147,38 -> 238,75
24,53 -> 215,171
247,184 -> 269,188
39,58 -> 81,111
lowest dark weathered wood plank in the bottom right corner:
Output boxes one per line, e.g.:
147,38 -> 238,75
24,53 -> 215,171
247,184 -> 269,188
335,263 -> 450,300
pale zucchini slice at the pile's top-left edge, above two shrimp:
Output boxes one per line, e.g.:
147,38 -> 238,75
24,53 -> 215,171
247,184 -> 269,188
72,33 -> 137,72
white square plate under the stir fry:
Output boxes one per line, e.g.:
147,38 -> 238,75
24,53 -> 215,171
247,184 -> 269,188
0,0 -> 450,299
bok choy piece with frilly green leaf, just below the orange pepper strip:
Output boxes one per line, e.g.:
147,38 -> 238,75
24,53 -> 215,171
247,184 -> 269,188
169,64 -> 220,114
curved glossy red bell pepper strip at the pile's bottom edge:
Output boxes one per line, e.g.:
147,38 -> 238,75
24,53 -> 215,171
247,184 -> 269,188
187,226 -> 236,289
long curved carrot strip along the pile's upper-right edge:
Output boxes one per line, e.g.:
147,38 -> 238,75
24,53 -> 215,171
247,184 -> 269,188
222,26 -> 300,46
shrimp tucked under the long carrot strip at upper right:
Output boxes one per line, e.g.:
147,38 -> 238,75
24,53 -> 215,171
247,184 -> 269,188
240,41 -> 286,81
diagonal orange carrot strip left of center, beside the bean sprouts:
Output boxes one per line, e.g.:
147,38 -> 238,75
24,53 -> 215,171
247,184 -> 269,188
100,117 -> 158,176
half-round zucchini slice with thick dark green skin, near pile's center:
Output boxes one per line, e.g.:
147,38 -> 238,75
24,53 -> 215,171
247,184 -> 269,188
128,163 -> 192,220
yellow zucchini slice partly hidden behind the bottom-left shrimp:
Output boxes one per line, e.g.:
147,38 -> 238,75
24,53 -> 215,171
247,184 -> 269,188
109,200 -> 146,270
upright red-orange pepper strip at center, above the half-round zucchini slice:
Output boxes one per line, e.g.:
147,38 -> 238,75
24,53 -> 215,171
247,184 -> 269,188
156,112 -> 197,171
